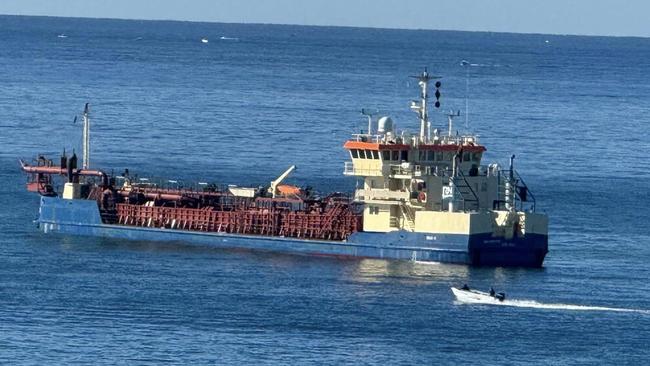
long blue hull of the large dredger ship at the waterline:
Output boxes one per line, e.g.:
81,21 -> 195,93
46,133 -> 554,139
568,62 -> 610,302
34,197 -> 547,267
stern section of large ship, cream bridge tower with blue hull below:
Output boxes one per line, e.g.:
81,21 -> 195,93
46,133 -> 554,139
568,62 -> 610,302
344,70 -> 548,266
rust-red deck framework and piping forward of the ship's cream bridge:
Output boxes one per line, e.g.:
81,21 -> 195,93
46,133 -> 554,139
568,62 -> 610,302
21,157 -> 363,241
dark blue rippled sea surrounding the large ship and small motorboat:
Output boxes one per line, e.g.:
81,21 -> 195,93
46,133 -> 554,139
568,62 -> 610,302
0,16 -> 650,365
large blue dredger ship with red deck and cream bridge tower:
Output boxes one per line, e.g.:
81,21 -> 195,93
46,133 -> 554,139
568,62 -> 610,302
21,70 -> 548,267
